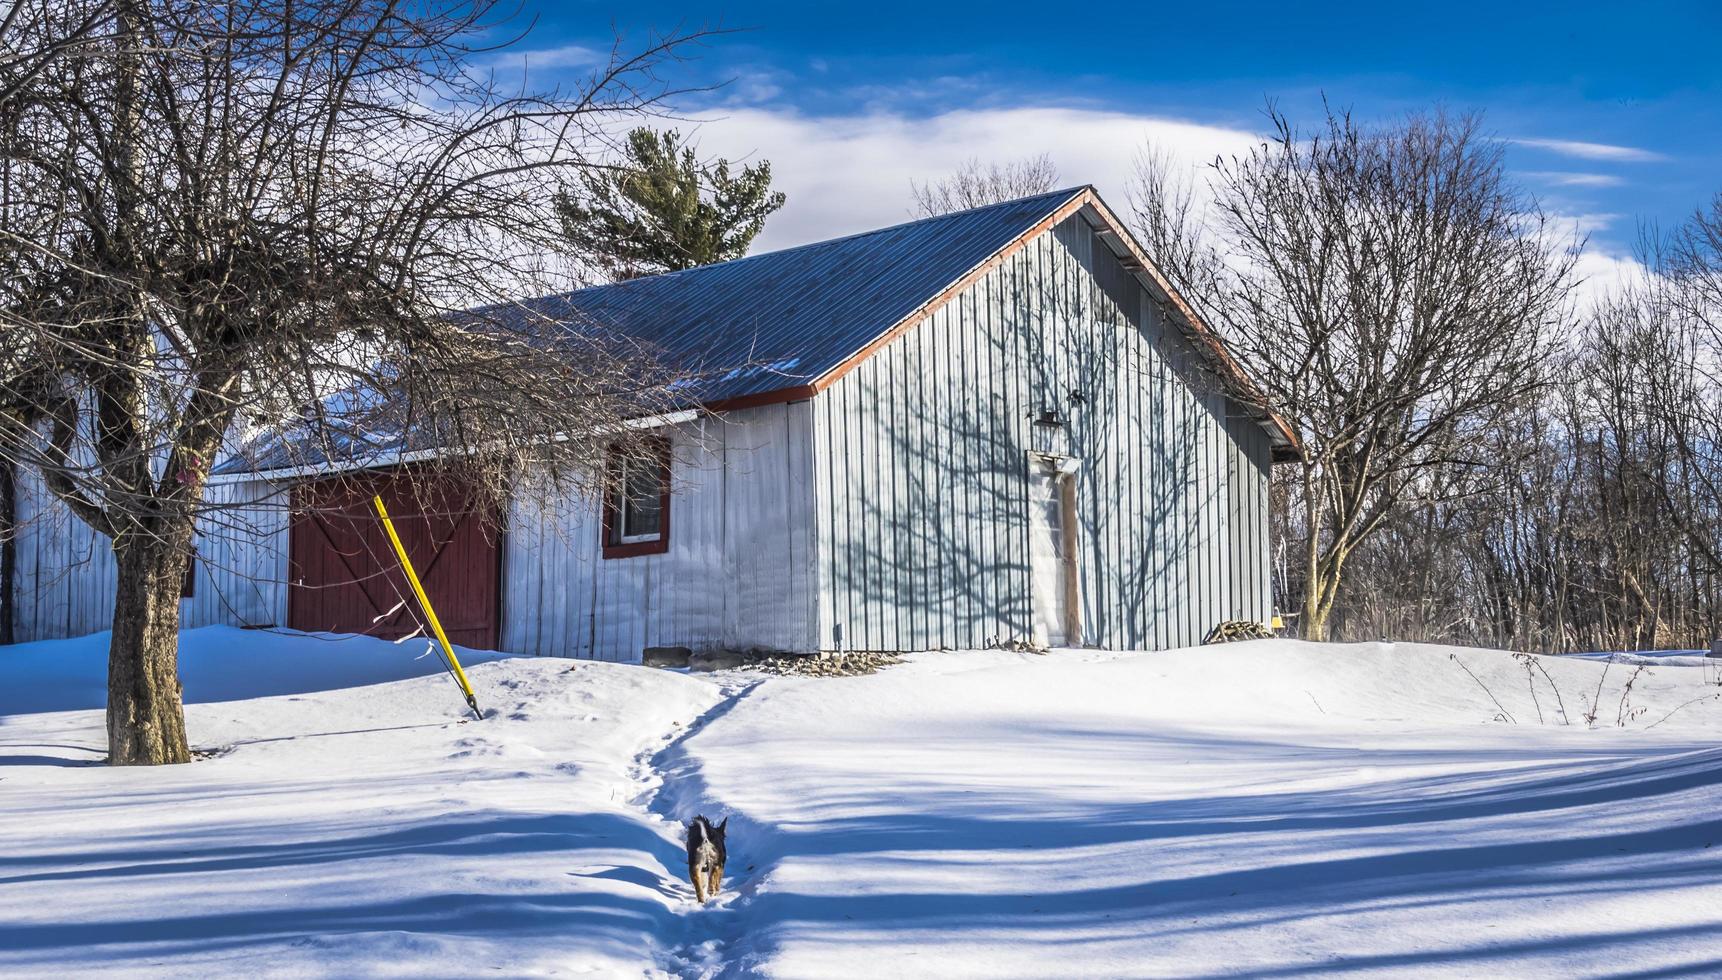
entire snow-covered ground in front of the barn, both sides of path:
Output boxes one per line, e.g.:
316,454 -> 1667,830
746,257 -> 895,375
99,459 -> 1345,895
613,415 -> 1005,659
0,630 -> 1722,977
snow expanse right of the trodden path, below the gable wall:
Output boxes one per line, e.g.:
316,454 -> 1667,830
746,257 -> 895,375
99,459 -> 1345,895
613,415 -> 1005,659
670,641 -> 1722,978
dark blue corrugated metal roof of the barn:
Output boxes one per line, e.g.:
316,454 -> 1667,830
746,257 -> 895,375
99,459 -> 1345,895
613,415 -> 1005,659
215,186 -> 1295,474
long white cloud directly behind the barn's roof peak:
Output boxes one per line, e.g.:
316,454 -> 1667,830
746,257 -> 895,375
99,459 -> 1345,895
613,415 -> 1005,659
697,109 -> 1259,251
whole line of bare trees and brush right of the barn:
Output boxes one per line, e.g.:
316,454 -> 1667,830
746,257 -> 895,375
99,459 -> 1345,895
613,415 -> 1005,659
1130,107 -> 1722,651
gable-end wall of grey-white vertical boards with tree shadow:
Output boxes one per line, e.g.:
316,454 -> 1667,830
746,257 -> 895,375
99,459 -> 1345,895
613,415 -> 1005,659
809,215 -> 1273,649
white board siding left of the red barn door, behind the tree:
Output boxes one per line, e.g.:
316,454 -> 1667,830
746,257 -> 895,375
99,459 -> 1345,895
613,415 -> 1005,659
12,467 -> 288,642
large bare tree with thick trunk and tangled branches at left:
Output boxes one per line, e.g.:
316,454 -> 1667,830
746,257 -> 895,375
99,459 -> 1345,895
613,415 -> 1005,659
0,0 -> 716,765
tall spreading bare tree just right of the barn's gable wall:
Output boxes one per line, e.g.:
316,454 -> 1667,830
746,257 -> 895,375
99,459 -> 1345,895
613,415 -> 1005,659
1131,107 -> 1577,639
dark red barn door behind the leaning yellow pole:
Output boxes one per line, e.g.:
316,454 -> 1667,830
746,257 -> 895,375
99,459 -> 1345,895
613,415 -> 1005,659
288,470 -> 501,649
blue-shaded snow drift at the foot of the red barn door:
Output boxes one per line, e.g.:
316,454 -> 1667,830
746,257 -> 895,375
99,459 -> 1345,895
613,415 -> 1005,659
0,627 -> 506,715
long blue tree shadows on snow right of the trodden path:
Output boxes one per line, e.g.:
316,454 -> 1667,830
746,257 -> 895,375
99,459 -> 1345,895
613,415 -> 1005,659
709,730 -> 1722,977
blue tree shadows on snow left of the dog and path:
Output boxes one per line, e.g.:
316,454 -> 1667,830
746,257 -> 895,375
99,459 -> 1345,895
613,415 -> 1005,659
0,813 -> 680,963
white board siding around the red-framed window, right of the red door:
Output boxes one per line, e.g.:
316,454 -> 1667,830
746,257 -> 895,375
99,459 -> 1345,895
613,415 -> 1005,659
501,401 -> 818,661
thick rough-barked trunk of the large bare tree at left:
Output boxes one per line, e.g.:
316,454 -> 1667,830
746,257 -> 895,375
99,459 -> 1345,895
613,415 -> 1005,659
107,532 -> 191,766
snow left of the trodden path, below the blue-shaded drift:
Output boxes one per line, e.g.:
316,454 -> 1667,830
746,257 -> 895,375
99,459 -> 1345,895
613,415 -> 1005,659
0,651 -> 718,977
